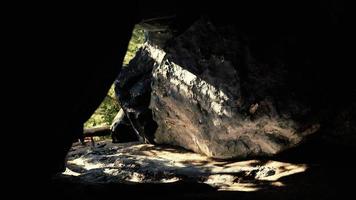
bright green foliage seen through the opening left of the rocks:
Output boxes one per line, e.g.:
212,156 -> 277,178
84,26 -> 144,128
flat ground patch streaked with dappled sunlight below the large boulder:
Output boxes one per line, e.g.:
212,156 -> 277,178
64,141 -> 307,191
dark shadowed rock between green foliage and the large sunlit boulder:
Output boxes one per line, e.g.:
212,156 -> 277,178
115,47 -> 157,143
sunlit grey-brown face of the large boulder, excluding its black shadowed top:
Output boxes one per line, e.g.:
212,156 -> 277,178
148,53 -> 308,159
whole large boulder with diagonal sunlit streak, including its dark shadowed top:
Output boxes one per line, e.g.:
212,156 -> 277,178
150,20 -> 319,159
